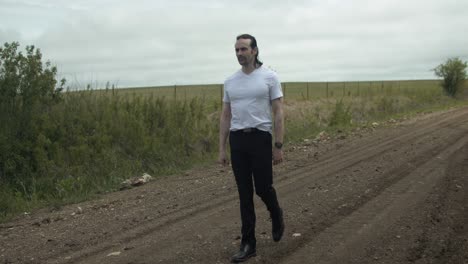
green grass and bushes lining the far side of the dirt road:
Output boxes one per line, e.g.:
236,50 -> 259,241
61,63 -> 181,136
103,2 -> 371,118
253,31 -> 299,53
0,43 -> 466,221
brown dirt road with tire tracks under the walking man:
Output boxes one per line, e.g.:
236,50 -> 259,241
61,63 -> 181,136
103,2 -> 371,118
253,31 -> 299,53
0,108 -> 468,264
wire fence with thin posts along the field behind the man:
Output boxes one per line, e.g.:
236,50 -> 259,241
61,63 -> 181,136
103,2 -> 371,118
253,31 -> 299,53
101,80 -> 468,101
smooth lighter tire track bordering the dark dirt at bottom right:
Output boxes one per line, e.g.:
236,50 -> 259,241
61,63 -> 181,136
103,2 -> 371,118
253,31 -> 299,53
276,129 -> 468,263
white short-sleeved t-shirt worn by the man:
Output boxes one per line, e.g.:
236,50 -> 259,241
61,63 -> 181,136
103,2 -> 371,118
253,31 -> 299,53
223,67 -> 283,133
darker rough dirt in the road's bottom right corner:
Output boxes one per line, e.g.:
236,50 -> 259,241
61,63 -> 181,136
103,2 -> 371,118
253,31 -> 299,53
348,134 -> 468,264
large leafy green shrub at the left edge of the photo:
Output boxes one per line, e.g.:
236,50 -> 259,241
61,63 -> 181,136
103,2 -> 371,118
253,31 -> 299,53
0,42 -> 65,202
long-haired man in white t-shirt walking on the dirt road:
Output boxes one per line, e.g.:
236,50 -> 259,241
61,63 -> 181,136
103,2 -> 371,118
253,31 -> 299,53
219,34 -> 284,262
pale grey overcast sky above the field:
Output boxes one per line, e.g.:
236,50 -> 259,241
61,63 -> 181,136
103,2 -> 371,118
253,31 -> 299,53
0,0 -> 468,87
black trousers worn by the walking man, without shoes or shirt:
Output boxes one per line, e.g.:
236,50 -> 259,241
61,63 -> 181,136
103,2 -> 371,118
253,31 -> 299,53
229,129 -> 280,245
